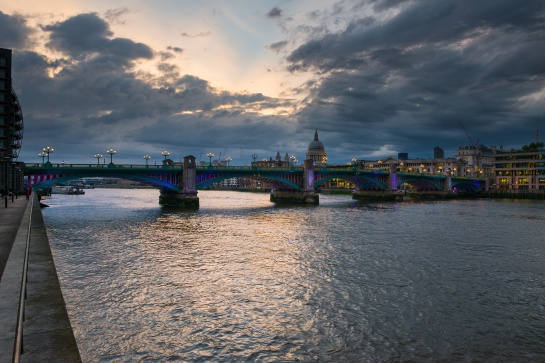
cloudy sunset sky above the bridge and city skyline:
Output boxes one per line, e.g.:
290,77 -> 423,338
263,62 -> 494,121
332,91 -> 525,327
0,0 -> 545,165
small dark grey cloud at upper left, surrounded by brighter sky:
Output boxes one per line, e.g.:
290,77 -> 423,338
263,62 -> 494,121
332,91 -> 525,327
44,13 -> 153,60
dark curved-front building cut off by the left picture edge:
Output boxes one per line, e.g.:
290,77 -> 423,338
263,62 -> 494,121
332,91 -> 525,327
0,48 -> 23,161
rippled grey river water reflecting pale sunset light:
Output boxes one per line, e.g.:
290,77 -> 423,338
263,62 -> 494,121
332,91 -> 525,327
43,189 -> 545,362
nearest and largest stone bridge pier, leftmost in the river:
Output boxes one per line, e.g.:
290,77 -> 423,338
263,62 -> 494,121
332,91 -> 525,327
159,155 -> 199,209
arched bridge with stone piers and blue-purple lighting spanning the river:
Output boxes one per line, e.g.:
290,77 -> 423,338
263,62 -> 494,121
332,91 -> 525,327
25,156 -> 485,207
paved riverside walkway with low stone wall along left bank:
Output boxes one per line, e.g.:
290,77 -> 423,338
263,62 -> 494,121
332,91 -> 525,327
0,194 -> 81,363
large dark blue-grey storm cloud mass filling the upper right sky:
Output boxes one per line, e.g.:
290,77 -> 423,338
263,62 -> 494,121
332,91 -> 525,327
287,0 -> 545,156
